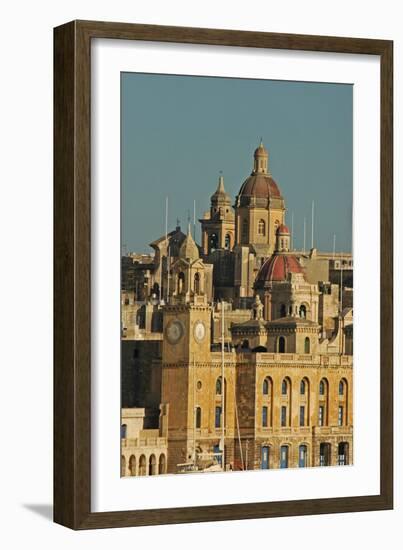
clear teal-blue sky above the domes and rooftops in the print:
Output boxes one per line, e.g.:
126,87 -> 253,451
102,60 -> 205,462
121,73 -> 353,252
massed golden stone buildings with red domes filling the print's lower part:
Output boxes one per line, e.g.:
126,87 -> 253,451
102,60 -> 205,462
122,142 -> 353,473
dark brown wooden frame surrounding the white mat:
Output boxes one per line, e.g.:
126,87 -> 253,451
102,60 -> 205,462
54,21 -> 393,529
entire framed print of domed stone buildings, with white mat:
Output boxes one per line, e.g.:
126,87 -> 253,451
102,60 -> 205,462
54,21 -> 393,529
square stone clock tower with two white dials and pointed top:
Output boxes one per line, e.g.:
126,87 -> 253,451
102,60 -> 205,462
161,231 -> 211,473
